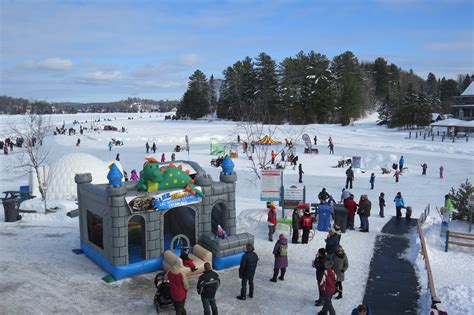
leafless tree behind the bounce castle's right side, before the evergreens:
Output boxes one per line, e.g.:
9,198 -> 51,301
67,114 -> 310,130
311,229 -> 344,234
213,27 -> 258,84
234,107 -> 304,179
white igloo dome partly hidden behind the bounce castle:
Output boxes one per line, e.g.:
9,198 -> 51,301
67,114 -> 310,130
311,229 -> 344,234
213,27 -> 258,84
47,153 -> 109,200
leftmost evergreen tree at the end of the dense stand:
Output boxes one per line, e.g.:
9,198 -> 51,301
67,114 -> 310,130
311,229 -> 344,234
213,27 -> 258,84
177,70 -> 210,119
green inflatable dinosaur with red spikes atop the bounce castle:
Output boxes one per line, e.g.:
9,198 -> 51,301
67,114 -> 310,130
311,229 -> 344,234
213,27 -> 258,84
137,158 -> 203,197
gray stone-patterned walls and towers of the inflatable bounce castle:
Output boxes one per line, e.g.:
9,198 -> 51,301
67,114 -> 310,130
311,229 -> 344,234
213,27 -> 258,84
75,161 -> 254,266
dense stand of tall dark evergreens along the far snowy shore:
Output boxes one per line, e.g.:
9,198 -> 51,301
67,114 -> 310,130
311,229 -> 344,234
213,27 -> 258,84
178,51 -> 471,127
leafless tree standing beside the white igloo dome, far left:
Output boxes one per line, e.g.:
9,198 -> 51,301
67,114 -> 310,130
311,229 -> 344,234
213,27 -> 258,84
10,113 -> 51,200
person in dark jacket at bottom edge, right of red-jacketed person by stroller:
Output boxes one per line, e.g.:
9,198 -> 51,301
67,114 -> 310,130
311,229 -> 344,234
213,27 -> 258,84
196,262 -> 221,315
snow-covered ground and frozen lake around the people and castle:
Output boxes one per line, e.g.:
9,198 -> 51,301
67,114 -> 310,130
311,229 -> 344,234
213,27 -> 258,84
0,113 -> 474,314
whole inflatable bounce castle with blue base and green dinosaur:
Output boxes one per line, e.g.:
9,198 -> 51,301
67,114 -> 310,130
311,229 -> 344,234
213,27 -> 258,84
75,157 -> 254,279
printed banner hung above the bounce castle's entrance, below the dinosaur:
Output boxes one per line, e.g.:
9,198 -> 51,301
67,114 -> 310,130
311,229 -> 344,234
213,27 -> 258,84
125,187 -> 202,212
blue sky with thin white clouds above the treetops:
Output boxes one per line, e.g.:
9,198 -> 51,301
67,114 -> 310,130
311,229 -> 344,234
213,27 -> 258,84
0,0 -> 474,102
